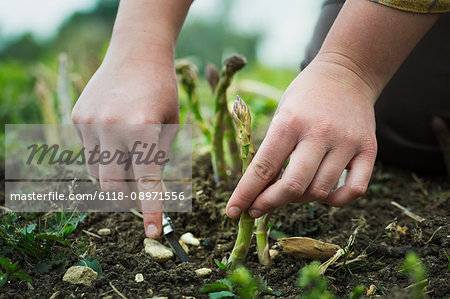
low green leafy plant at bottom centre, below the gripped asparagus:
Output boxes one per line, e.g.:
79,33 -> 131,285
198,266 -> 281,299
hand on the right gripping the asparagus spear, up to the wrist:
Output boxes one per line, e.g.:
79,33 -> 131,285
227,55 -> 377,218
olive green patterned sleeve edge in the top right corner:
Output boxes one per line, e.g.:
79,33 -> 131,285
370,0 -> 450,13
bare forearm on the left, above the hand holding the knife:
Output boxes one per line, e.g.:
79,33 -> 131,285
107,0 -> 192,62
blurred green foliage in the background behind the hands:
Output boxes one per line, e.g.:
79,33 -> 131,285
0,0 -> 296,160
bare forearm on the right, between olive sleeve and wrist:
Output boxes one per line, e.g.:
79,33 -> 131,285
315,0 -> 438,100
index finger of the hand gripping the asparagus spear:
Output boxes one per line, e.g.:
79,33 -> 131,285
226,122 -> 298,218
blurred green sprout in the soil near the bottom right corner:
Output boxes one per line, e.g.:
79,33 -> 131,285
402,252 -> 427,299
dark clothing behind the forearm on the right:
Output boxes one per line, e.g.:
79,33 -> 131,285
301,0 -> 450,173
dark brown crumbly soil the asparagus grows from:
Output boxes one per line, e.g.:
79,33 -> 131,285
0,156 -> 450,298
